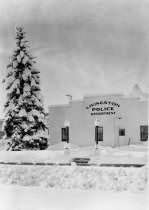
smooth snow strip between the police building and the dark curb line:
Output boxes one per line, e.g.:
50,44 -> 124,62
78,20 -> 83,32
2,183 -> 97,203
0,143 -> 148,164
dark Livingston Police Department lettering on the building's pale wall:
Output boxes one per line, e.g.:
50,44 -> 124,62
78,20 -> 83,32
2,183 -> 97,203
86,101 -> 120,115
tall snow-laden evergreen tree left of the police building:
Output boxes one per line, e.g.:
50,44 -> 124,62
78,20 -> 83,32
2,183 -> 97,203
3,27 -> 48,151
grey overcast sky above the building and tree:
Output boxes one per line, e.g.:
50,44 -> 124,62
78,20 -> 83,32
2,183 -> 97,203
0,0 -> 149,117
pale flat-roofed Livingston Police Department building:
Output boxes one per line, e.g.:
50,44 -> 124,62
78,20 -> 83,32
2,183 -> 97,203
49,85 -> 148,147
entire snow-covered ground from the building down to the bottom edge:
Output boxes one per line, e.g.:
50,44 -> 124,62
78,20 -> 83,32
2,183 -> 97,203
0,143 -> 148,210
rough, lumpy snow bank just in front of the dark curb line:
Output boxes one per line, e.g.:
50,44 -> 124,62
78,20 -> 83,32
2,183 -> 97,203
0,165 -> 147,192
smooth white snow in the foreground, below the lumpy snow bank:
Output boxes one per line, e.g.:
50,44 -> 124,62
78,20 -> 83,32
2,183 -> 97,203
0,185 -> 148,210
